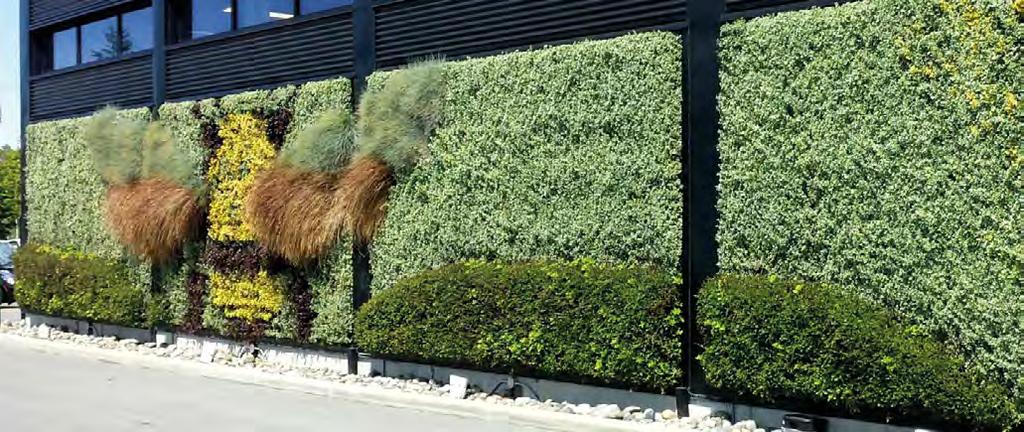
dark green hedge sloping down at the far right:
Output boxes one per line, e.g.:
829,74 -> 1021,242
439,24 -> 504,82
697,274 -> 1021,430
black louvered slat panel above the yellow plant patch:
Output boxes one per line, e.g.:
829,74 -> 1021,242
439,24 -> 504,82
167,11 -> 353,100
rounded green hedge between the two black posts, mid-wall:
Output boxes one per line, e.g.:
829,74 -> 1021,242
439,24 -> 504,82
355,261 -> 684,391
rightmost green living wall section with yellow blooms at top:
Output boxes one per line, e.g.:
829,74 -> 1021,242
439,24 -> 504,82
718,0 -> 1024,395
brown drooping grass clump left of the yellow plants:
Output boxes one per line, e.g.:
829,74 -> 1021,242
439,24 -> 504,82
105,178 -> 203,262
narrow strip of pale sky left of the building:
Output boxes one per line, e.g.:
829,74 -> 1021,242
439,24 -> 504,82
0,0 -> 22,146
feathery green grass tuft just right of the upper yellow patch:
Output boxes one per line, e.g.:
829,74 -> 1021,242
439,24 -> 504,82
278,110 -> 355,173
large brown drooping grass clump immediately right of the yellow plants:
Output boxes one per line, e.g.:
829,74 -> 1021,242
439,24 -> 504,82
246,164 -> 346,264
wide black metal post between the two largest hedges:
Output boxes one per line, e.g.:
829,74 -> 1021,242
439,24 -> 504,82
683,0 -> 725,396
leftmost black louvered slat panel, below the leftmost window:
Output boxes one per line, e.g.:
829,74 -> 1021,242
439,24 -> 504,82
30,55 -> 153,122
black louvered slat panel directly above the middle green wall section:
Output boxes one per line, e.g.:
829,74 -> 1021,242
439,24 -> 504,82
376,0 -> 686,68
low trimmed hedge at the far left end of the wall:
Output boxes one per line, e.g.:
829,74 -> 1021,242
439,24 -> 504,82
14,244 -> 151,328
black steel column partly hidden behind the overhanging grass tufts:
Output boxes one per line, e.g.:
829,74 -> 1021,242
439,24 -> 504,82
352,0 -> 377,311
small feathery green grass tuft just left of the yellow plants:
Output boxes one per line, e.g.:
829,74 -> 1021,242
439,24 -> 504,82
141,122 -> 203,191
